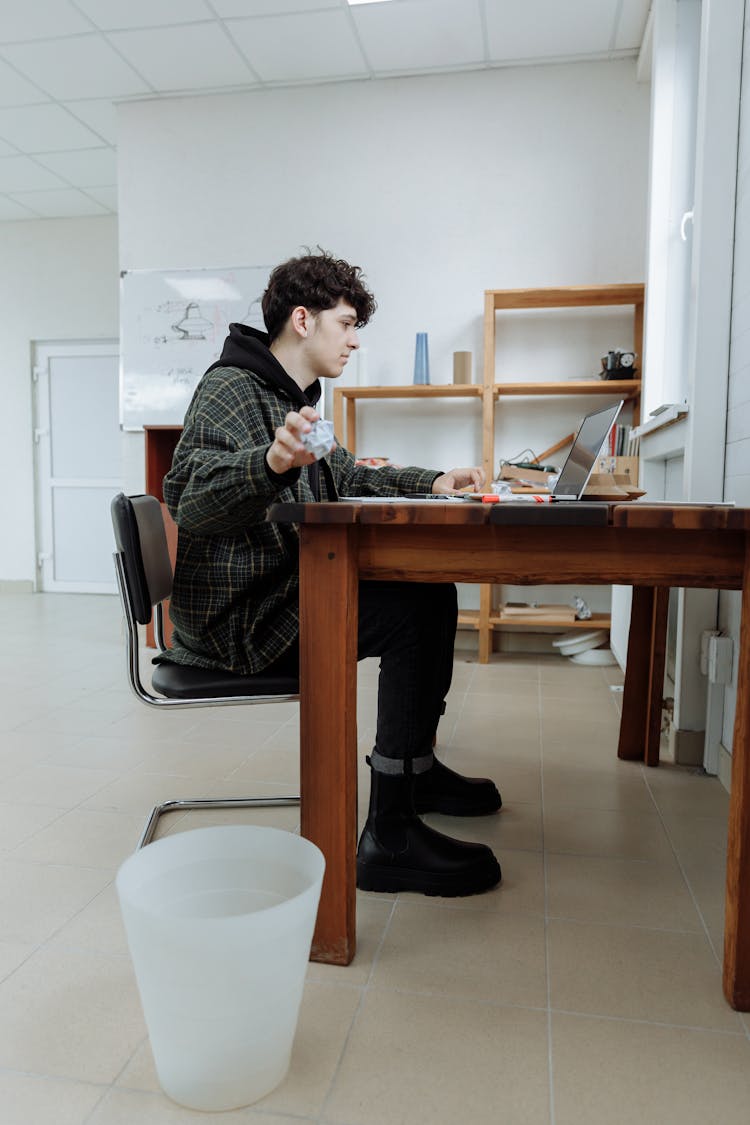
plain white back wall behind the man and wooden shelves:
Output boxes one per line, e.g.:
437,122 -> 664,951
119,62 -> 649,479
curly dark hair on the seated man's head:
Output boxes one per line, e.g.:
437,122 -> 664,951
262,246 -> 377,342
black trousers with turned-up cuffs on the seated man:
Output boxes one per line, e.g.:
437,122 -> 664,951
265,582 -> 458,774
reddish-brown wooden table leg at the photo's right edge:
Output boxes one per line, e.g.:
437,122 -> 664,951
724,546 -> 750,1011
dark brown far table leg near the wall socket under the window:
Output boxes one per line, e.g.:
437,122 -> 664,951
617,586 -> 669,766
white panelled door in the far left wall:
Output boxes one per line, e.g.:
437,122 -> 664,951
34,341 -> 123,594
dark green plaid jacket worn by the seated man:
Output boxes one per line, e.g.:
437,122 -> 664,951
159,367 -> 440,675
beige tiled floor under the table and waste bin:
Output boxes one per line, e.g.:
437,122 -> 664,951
0,595 -> 750,1125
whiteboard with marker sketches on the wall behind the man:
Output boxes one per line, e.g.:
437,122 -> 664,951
120,266 -> 272,430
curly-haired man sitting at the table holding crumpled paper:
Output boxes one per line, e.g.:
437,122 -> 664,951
164,252 -> 501,896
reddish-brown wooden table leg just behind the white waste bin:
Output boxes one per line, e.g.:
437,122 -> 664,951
299,524 -> 358,965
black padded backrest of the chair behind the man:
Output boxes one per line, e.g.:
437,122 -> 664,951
110,493 -> 172,626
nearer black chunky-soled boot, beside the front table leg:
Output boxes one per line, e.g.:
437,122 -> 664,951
356,770 -> 501,898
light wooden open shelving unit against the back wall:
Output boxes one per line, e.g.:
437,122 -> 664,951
334,284 -> 645,663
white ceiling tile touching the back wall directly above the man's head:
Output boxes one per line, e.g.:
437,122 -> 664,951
227,10 -> 367,82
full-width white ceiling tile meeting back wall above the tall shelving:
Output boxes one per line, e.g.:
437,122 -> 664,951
485,0 -> 617,62
